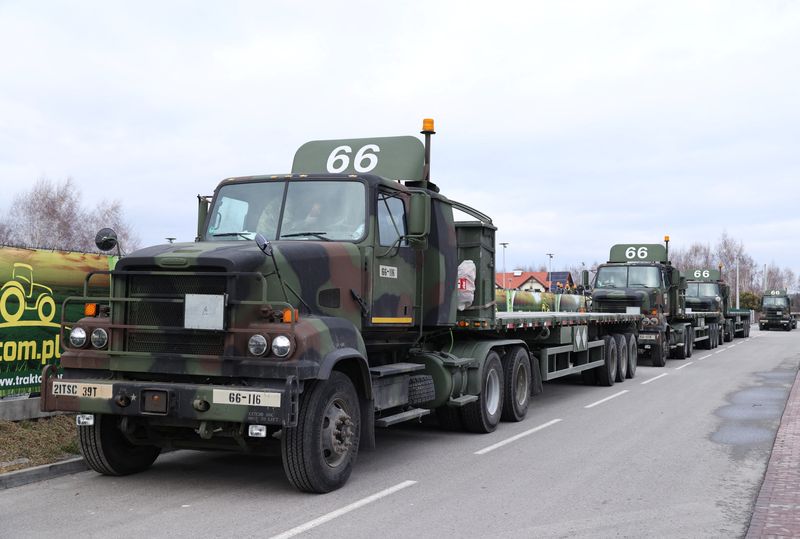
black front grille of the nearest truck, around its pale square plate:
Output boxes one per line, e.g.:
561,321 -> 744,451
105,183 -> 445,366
125,267 -> 229,355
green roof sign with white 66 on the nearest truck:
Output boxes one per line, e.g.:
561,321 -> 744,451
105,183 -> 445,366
292,137 -> 425,180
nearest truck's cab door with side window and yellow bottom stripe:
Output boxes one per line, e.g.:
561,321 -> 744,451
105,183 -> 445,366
367,189 -> 417,328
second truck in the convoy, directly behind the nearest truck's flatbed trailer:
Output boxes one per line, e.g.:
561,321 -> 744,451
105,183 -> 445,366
592,240 -> 722,367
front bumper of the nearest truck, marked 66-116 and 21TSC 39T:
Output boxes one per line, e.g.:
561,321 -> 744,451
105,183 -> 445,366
41,365 -> 300,427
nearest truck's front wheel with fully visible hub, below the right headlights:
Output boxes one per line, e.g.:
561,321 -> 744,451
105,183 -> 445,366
281,371 -> 361,494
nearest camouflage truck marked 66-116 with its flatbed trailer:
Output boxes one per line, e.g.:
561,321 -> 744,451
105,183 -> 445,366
41,121 -> 641,492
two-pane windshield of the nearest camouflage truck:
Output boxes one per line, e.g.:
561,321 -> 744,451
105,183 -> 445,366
205,180 -> 366,241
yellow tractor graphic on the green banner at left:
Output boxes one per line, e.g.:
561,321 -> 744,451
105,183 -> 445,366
0,262 -> 56,323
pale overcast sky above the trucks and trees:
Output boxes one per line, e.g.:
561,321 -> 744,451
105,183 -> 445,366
0,0 -> 800,272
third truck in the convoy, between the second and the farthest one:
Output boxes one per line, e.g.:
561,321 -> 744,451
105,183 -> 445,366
683,269 -> 750,342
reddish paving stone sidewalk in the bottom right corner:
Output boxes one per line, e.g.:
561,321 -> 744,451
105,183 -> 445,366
747,372 -> 800,538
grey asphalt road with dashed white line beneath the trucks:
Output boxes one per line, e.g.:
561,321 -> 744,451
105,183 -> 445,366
0,329 -> 800,538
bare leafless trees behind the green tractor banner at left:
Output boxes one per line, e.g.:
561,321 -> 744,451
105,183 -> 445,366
0,178 -> 138,251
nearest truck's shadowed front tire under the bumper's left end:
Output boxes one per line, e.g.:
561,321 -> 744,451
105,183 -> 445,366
78,414 -> 161,475
